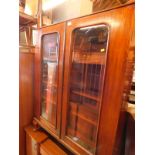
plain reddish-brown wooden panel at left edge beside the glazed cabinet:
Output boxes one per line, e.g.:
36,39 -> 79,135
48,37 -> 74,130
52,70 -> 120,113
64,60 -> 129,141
19,49 -> 34,155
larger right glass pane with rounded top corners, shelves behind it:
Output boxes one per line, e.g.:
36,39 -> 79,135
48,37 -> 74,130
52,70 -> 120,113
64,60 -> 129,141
67,25 -> 108,153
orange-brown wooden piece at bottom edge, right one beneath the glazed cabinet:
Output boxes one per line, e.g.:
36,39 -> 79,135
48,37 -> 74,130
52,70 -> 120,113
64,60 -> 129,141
40,139 -> 67,155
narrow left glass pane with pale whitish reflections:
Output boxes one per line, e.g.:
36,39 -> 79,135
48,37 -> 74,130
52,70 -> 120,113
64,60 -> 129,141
41,33 -> 58,126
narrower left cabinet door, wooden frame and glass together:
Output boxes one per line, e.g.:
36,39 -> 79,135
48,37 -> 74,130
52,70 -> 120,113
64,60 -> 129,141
36,23 -> 65,135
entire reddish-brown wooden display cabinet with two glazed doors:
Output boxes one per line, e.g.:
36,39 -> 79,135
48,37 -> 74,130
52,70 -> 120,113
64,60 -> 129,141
35,4 -> 134,155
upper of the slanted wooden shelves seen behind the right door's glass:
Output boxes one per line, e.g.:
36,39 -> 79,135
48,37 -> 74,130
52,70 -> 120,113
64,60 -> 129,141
72,90 -> 100,101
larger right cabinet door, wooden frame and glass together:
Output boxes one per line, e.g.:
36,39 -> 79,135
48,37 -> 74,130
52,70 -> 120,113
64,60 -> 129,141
61,5 -> 133,155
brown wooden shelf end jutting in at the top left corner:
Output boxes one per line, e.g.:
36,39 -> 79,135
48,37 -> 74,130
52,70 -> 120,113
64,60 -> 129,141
19,12 -> 37,26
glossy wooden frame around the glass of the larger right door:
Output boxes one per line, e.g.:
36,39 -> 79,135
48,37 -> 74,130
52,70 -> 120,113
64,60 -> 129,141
61,4 -> 134,155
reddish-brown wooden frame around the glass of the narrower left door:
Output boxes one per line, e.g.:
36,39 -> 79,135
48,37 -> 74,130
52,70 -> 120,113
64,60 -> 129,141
34,23 -> 65,137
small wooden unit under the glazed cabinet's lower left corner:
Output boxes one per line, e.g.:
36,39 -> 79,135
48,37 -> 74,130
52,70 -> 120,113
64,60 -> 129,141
25,126 -> 48,155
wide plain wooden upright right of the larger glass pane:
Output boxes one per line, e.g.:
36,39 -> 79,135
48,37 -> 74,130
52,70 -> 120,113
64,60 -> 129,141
97,5 -> 134,155
